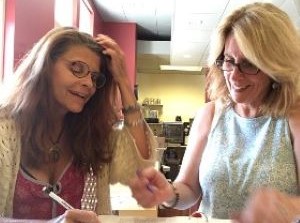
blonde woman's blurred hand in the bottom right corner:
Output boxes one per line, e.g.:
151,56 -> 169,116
233,189 -> 300,223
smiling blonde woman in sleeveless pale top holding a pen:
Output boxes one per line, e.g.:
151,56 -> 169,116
131,3 -> 300,223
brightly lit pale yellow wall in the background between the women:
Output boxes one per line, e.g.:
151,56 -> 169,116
137,73 -> 205,121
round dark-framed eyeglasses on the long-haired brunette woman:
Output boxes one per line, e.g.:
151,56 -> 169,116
67,60 -> 106,89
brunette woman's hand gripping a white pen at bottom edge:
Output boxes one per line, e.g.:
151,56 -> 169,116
49,209 -> 101,223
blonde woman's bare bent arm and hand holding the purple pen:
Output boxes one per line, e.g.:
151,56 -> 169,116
130,103 -> 214,209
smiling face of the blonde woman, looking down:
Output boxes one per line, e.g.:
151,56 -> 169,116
224,35 -> 271,107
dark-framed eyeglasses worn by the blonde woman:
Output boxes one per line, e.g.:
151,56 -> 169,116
215,60 -> 260,75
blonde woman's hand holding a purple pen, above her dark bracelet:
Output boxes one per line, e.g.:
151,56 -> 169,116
129,167 -> 174,208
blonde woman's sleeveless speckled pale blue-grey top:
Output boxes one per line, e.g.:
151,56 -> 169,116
199,108 -> 300,219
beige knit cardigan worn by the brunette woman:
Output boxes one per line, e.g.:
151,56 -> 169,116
0,112 -> 156,217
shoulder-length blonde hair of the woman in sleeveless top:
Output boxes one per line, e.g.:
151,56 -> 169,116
208,3 -> 300,117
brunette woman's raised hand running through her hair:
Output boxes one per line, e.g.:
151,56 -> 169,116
95,34 -> 127,83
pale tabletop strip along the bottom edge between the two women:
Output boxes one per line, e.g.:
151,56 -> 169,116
99,215 -> 231,223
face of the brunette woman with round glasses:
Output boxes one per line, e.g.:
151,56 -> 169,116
51,45 -> 100,114
